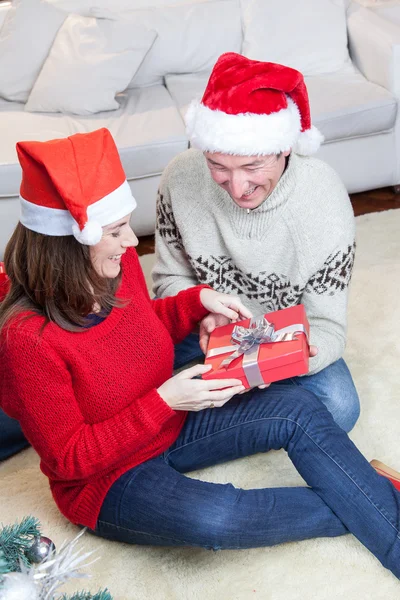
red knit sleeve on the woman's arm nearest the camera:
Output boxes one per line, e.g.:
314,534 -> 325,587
0,329 -> 176,481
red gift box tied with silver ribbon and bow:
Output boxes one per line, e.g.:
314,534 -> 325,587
203,304 -> 310,389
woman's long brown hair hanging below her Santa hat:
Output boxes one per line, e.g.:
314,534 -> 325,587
0,223 -> 123,332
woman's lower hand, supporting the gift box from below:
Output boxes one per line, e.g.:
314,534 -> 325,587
157,365 -> 244,411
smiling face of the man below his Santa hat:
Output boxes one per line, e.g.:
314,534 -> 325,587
204,151 -> 290,209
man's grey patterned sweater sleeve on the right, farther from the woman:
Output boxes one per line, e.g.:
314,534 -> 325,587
291,158 -> 355,375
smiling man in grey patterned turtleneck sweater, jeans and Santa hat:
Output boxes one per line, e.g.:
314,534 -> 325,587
153,53 -> 359,431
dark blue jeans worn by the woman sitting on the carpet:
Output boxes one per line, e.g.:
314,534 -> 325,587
94,384 -> 400,577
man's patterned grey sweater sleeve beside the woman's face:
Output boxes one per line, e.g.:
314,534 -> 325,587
152,182 -> 198,297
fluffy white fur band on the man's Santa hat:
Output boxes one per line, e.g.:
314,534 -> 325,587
185,97 -> 318,156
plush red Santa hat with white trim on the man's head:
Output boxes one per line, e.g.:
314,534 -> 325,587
186,52 -> 323,156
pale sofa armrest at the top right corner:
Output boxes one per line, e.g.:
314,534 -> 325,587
347,8 -> 400,98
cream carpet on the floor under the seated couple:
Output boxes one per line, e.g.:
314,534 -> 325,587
0,210 -> 400,600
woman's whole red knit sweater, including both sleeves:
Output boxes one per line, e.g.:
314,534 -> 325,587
0,249 -> 207,528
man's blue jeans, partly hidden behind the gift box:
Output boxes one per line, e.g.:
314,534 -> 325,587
174,333 -> 360,432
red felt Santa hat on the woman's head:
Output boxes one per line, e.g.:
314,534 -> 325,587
17,128 -> 136,246
